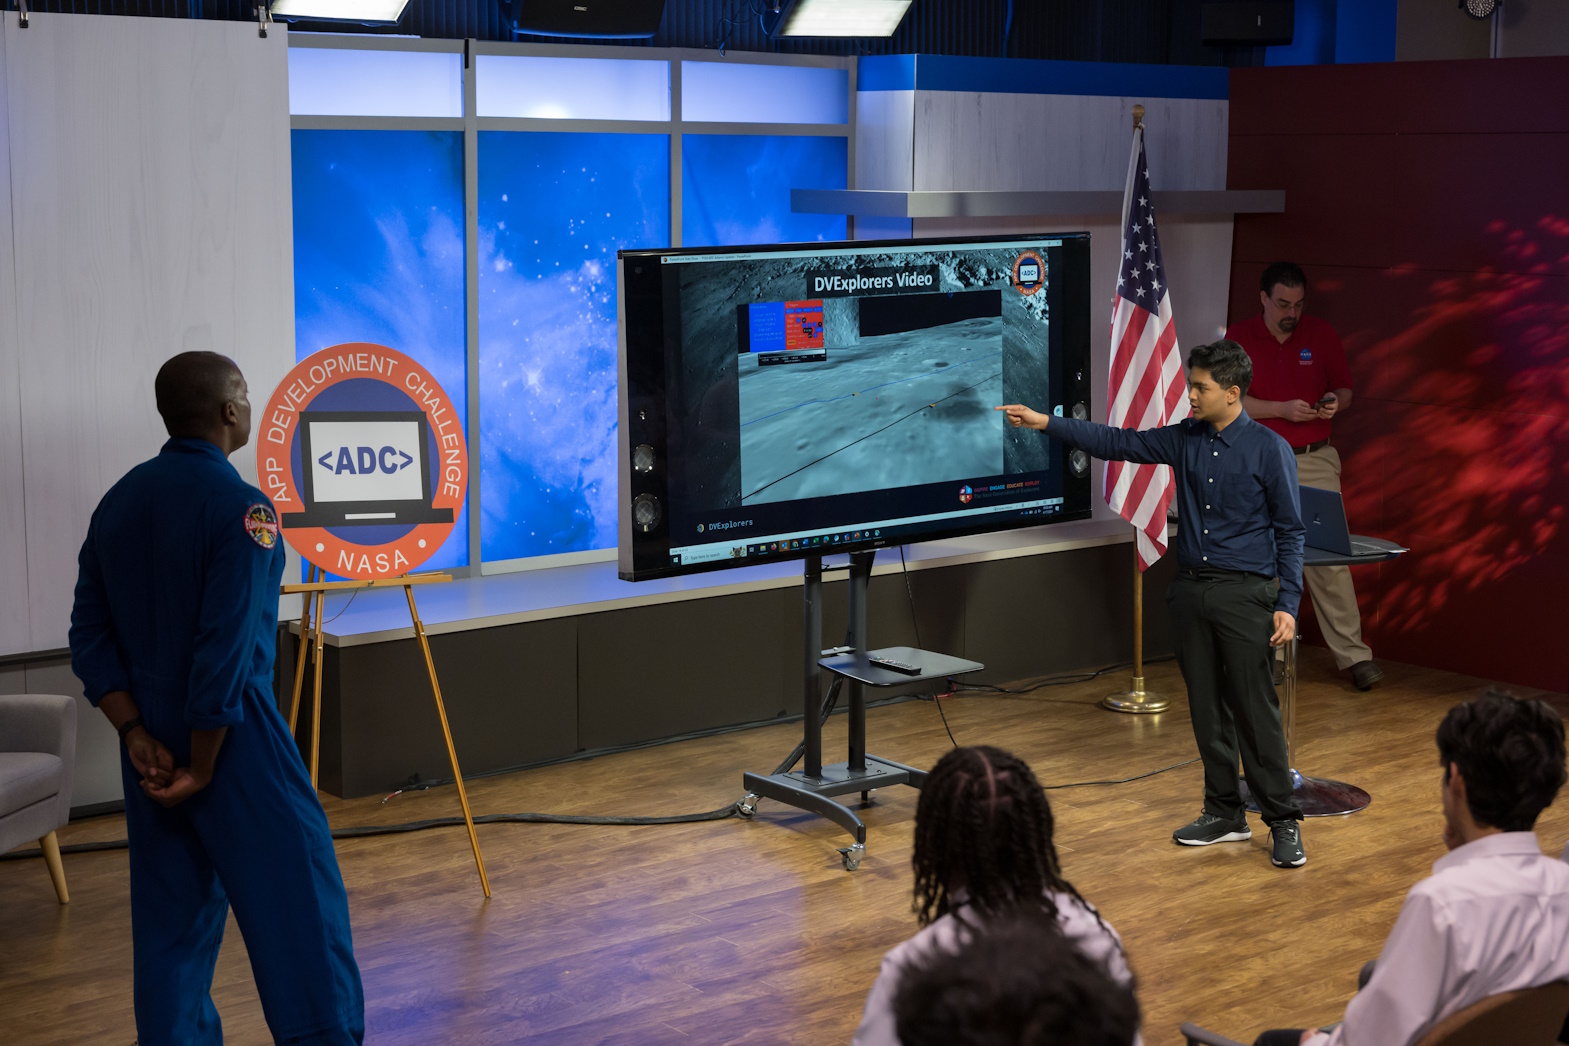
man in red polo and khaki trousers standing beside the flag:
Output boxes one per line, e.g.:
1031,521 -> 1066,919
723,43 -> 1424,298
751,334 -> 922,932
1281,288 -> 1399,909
1225,262 -> 1384,690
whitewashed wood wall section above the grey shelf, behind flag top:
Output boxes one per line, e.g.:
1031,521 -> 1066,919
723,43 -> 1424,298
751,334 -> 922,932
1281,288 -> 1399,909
913,91 -> 1227,190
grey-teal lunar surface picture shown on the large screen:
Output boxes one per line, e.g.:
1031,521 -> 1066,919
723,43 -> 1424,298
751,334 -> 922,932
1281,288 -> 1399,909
737,290 -> 1004,505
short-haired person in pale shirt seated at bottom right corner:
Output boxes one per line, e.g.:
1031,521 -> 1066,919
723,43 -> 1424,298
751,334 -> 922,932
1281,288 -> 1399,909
1255,690 -> 1569,1046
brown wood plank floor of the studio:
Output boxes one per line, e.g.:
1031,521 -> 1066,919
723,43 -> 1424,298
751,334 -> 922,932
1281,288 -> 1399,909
9,649 -> 1569,1046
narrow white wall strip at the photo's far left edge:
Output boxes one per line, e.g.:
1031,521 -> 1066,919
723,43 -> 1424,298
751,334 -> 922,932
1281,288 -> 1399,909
0,32 -> 28,654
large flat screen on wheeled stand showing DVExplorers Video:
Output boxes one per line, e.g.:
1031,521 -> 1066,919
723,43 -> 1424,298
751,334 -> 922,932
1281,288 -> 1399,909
617,234 -> 1089,580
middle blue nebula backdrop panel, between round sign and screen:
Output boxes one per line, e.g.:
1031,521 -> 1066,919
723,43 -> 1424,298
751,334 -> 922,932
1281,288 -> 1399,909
479,130 -> 670,561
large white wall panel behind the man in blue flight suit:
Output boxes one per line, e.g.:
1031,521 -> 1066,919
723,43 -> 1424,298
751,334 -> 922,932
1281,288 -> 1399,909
5,14 -> 293,649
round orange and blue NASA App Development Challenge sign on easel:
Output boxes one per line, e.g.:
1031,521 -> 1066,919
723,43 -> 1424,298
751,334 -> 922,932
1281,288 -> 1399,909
254,342 -> 469,577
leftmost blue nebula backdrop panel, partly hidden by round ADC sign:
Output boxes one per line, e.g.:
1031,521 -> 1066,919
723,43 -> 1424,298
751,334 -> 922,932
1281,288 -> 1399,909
292,130 -> 472,569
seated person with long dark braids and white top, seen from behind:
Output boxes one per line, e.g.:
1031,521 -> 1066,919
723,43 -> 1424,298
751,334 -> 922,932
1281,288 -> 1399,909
852,746 -> 1138,1046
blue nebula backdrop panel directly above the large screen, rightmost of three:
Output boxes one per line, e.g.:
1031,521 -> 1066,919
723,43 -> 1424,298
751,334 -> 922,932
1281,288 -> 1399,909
681,135 -> 849,246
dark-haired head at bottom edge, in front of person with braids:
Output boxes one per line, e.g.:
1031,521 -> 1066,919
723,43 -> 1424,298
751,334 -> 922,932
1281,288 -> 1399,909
894,908 -> 1139,1046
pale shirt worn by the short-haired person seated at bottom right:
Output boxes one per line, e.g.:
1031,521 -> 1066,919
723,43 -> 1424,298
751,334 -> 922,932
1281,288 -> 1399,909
1309,831 -> 1569,1046
